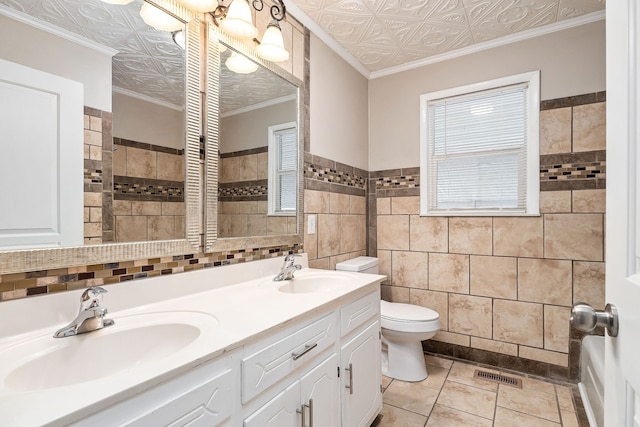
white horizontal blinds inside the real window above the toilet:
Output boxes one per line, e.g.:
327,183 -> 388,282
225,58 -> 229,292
427,84 -> 528,212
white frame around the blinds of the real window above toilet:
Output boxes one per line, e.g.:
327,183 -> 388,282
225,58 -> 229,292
420,70 -> 540,216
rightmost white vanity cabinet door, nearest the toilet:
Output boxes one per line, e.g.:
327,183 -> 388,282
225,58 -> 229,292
340,320 -> 382,427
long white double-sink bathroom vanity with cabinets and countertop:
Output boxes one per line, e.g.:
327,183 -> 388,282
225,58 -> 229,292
0,257 -> 384,427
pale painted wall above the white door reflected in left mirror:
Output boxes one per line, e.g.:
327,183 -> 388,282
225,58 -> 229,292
0,15 -> 111,111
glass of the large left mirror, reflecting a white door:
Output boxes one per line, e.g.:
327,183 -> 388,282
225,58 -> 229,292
0,0 -> 185,250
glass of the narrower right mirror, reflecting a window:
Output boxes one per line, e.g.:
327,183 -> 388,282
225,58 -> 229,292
218,44 -> 299,238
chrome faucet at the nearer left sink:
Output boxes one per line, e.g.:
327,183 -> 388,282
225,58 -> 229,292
53,286 -> 114,338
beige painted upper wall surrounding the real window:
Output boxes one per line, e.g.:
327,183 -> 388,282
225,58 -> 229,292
368,21 -> 605,171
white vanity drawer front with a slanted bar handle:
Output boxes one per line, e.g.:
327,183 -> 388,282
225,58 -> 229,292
242,313 -> 338,403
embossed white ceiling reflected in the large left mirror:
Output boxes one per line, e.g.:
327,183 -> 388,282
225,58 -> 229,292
0,0 -> 184,108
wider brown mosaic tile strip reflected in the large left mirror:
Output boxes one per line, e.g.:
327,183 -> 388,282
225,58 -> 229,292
113,175 -> 184,202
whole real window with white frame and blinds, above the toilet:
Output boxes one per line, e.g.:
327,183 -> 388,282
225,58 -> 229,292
420,71 -> 540,216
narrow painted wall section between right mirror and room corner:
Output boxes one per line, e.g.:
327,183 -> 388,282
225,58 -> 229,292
310,35 -> 369,169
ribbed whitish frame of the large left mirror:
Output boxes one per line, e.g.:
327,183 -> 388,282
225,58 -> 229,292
0,0 -> 202,274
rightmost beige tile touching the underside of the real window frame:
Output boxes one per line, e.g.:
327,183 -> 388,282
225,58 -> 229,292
493,217 -> 543,258
